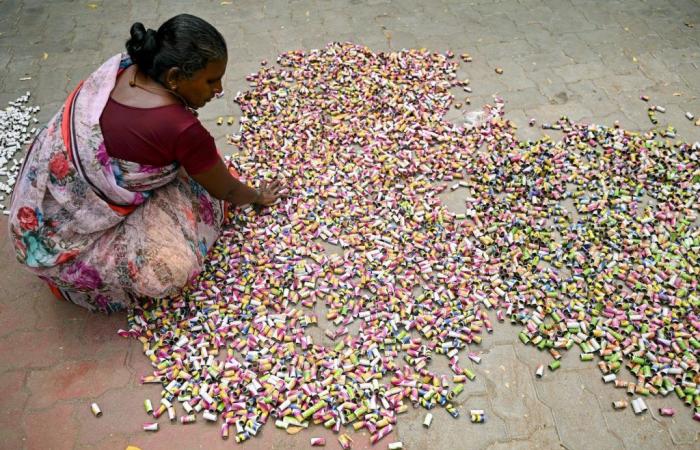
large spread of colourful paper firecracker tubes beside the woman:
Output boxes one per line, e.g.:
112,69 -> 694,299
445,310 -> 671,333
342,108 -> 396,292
104,43 -> 700,449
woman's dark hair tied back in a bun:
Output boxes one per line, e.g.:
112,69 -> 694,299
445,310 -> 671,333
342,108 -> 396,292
126,14 -> 227,82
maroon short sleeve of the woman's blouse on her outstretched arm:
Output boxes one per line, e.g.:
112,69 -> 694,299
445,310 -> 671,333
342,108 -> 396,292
175,121 -> 220,175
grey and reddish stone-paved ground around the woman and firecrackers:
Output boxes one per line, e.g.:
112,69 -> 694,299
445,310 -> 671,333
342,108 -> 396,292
0,0 -> 700,450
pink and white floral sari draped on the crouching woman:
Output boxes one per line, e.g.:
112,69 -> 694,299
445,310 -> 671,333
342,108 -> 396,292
9,55 -> 224,312
